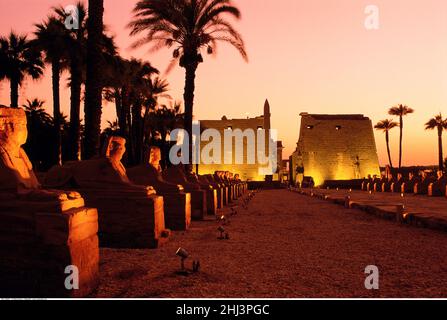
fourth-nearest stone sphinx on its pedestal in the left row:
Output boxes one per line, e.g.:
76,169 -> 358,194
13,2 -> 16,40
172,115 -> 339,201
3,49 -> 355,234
163,164 -> 207,220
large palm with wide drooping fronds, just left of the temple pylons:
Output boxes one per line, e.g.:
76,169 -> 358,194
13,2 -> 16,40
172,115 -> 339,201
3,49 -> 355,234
129,0 -> 248,170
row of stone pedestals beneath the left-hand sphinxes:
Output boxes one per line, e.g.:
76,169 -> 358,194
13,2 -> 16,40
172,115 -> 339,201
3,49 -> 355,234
0,183 -> 246,297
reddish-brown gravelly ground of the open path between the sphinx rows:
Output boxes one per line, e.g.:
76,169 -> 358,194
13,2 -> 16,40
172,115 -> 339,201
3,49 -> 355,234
95,190 -> 447,298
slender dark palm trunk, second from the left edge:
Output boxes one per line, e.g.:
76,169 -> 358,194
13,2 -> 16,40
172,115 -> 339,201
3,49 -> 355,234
51,59 -> 62,165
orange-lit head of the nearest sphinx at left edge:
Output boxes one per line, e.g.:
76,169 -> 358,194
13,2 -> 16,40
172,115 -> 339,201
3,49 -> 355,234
0,106 -> 28,148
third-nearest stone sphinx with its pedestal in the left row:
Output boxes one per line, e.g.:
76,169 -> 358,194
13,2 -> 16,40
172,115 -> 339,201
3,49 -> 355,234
127,146 -> 191,230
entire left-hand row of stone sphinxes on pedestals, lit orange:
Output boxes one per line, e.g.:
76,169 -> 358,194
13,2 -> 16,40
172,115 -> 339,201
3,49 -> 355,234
0,106 -> 246,297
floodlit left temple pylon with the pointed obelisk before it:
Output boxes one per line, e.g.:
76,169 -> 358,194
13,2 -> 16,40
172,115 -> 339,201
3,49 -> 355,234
199,100 -> 282,181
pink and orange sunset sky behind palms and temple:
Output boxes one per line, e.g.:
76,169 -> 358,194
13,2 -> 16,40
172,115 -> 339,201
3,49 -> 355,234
0,0 -> 447,165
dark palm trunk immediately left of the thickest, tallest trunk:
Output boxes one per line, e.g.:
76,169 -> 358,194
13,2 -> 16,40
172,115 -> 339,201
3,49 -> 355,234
69,56 -> 82,161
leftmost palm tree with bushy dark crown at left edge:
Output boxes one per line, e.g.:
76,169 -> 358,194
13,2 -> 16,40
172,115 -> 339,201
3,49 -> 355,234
0,32 -> 44,108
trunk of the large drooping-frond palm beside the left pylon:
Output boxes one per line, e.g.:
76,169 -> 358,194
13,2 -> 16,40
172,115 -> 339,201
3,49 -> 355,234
183,63 -> 198,172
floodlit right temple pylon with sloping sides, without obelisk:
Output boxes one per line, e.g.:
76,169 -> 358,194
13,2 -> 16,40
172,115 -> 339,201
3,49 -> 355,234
290,113 -> 380,186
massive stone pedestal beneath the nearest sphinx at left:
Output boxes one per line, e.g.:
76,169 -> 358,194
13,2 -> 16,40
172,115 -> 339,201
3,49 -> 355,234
0,197 -> 99,298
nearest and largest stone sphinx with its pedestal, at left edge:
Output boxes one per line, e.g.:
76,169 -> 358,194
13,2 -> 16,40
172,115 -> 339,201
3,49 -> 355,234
0,106 -> 99,297
